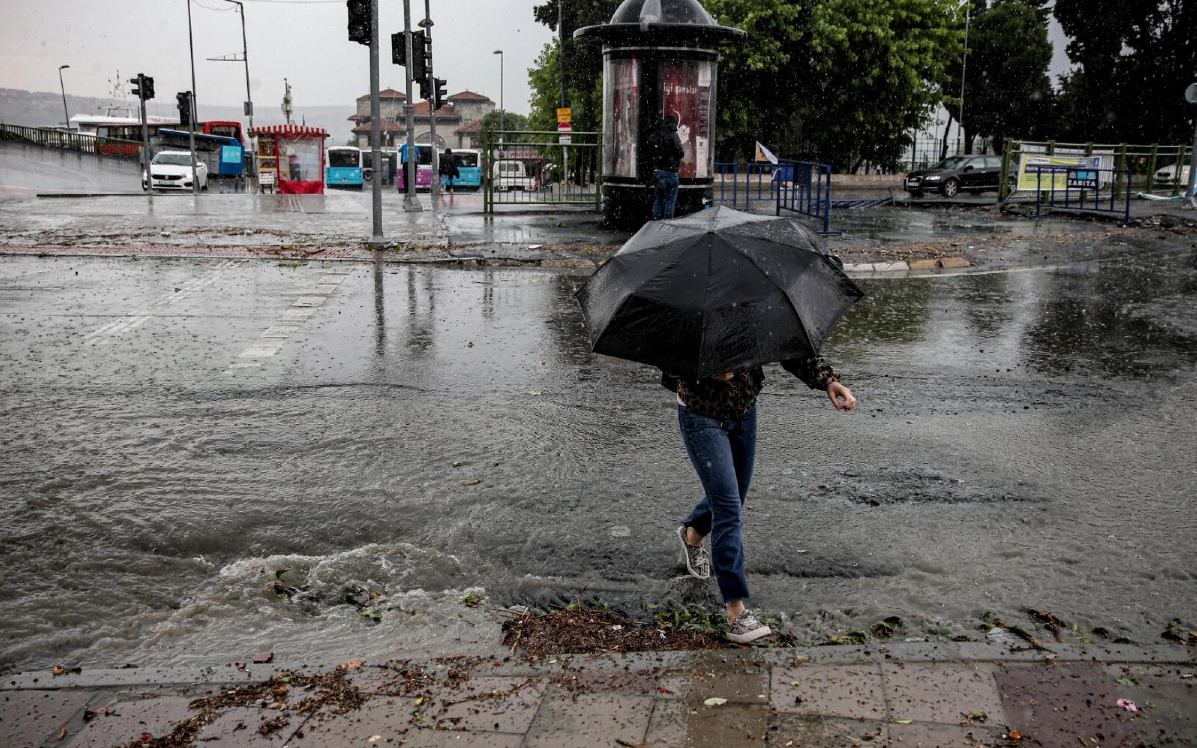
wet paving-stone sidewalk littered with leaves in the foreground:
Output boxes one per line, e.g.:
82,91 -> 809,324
0,643 -> 1197,748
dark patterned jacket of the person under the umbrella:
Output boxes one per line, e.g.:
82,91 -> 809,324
661,354 -> 839,420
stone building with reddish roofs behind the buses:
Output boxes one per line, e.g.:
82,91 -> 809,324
350,89 -> 494,148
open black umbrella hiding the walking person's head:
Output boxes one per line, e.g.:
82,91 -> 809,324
578,208 -> 863,381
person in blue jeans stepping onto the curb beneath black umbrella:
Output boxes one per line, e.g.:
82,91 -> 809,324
661,356 -> 856,644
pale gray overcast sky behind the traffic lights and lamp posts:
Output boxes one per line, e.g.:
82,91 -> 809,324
0,0 -> 552,114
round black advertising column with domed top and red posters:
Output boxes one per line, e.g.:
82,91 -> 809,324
573,0 -> 747,227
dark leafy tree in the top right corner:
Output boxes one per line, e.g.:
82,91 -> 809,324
1053,0 -> 1197,144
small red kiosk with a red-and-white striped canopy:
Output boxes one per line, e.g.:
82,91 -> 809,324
249,124 -> 328,195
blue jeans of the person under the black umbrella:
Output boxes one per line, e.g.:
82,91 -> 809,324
678,406 -> 757,603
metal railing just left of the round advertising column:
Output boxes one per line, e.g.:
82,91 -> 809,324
482,130 -> 602,213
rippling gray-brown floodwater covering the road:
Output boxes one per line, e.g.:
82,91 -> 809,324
0,250 -> 1197,669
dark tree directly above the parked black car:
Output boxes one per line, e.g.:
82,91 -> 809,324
944,0 -> 1053,153
